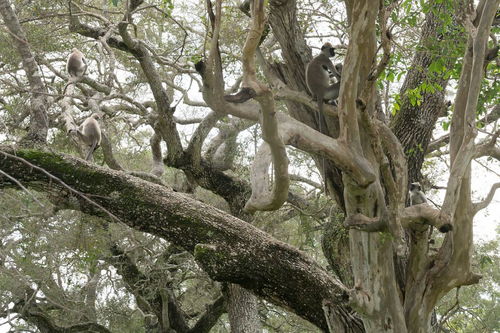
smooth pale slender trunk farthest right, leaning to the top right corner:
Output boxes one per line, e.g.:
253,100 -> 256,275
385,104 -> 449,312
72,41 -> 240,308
405,0 -> 499,333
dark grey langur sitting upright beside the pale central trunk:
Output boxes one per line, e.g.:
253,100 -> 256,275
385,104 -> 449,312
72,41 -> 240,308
306,43 -> 342,114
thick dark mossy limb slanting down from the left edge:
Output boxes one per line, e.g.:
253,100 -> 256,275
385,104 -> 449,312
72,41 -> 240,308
0,147 -> 347,329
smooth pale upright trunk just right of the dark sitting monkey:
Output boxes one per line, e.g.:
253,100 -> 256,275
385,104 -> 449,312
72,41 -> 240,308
332,1 -> 406,333
